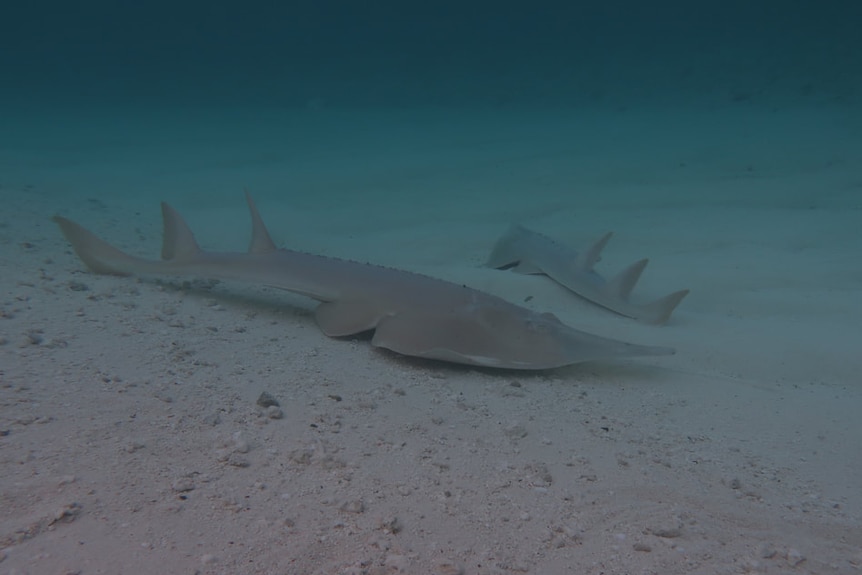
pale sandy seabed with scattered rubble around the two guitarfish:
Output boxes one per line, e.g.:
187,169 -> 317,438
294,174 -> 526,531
0,109 -> 862,575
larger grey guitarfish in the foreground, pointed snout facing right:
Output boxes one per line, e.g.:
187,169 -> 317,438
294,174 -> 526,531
54,194 -> 674,370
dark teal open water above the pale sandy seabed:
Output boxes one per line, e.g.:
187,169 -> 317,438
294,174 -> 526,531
0,0 -> 862,109
